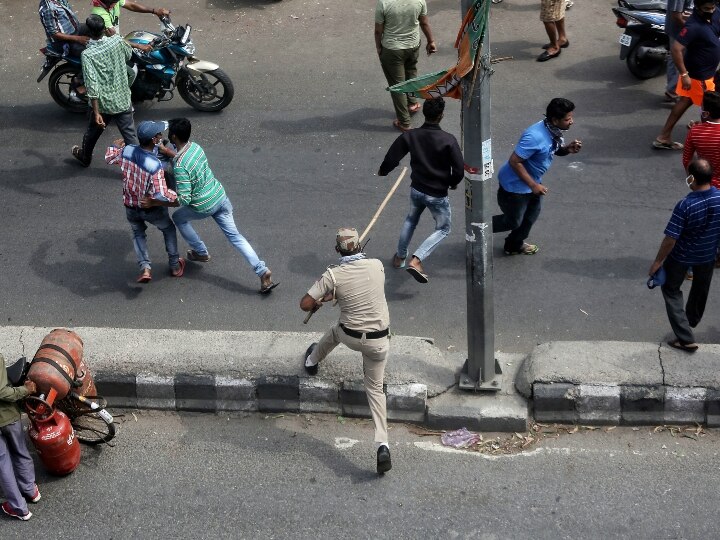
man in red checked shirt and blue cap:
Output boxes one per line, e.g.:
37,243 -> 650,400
105,121 -> 185,283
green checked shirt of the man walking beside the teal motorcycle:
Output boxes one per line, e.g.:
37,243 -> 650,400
81,34 -> 132,114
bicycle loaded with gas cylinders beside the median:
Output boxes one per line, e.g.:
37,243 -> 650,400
7,356 -> 116,445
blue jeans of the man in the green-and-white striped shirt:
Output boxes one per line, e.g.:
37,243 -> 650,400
173,197 -> 268,277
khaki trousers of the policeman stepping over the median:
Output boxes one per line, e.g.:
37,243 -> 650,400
309,324 -> 390,443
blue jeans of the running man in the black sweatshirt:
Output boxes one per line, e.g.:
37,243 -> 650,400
397,188 -> 452,261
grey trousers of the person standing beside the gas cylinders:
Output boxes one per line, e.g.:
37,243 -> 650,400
0,420 -> 35,515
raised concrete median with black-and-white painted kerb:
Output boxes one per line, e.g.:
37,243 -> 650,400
5,326 -> 720,432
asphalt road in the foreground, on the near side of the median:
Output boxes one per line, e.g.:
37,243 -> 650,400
7,411 -> 720,540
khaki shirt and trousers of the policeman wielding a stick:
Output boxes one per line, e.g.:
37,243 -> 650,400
308,259 -> 390,442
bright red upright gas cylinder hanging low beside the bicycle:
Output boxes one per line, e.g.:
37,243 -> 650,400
25,392 -> 80,475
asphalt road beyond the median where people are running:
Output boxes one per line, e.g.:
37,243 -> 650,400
0,0 -> 720,352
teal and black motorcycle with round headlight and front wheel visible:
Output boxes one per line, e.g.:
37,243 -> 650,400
37,17 -> 235,113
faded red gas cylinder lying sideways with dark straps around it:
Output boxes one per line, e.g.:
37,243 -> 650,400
28,328 -> 86,399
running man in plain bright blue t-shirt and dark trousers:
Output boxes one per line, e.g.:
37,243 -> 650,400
493,98 -> 582,255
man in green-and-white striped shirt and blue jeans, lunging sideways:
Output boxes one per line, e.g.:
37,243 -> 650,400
143,118 -> 278,294
